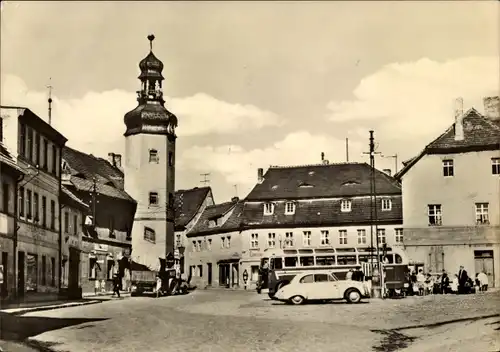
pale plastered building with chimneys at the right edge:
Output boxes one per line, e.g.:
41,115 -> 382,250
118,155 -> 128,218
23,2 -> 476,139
396,97 -> 500,287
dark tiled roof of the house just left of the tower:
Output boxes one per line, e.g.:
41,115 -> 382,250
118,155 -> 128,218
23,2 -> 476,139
63,147 -> 123,188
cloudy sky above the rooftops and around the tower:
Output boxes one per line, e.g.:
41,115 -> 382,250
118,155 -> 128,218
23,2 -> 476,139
0,1 -> 500,202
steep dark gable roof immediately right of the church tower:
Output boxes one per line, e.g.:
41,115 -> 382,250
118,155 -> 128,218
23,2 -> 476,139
174,187 -> 212,229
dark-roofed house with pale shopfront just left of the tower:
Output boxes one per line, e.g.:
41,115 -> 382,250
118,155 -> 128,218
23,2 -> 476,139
62,147 -> 137,293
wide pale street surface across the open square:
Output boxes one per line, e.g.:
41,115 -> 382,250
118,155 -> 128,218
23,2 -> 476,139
0,290 -> 500,352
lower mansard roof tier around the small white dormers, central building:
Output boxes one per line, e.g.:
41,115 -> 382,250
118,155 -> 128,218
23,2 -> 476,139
242,195 -> 403,228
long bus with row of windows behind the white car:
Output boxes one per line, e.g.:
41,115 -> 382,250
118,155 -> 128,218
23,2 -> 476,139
257,246 -> 408,298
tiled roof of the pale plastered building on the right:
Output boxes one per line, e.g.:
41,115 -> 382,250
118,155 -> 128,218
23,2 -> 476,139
394,108 -> 500,179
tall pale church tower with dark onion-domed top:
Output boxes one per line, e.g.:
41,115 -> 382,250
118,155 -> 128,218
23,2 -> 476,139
124,35 -> 177,269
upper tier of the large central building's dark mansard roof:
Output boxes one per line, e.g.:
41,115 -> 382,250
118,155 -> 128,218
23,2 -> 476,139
246,163 -> 401,200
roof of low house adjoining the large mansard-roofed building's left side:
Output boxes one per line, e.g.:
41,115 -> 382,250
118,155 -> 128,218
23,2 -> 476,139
188,202 -> 243,235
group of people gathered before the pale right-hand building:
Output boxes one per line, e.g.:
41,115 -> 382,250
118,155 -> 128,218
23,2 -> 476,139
410,266 -> 488,296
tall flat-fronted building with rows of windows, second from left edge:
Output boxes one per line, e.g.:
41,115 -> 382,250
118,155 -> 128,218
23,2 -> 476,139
1,107 -> 67,297
